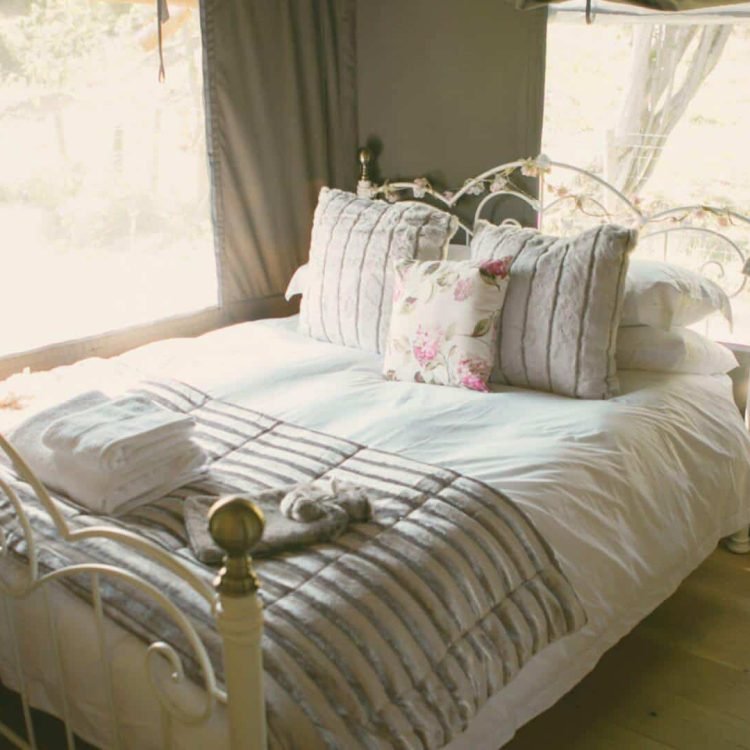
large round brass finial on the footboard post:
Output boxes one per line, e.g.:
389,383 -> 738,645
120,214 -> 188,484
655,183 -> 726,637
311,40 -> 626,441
208,495 -> 266,596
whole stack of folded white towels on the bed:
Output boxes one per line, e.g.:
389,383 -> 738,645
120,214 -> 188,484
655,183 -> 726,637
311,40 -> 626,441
10,391 -> 206,515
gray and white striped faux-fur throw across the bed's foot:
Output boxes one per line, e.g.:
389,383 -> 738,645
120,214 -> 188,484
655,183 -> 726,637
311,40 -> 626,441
0,381 -> 585,750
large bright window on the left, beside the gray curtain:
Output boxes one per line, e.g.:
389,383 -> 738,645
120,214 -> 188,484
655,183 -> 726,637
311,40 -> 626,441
0,0 -> 217,356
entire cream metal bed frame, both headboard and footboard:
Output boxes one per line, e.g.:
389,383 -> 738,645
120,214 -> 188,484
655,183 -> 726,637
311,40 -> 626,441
0,149 -> 750,750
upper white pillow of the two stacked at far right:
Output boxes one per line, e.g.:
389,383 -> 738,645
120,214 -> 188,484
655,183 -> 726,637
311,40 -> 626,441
620,260 -> 732,330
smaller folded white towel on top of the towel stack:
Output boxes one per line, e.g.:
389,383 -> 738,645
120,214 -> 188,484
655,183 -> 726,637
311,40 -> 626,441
42,392 -> 195,471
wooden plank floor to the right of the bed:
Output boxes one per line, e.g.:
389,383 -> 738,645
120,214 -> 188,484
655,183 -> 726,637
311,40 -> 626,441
0,550 -> 750,750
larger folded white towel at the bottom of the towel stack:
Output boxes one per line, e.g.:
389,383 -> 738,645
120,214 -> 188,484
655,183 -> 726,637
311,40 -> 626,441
10,392 -> 206,515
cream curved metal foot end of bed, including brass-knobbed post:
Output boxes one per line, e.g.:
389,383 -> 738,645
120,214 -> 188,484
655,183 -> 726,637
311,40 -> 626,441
0,435 -> 266,750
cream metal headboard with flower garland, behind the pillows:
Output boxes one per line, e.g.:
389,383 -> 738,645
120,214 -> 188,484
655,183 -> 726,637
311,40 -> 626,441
357,149 -> 750,312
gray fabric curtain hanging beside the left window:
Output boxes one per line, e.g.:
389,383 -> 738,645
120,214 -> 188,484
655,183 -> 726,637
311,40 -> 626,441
201,0 -> 357,319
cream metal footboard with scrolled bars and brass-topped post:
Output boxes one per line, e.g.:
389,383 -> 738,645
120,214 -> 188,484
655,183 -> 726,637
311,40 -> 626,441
0,435 -> 266,750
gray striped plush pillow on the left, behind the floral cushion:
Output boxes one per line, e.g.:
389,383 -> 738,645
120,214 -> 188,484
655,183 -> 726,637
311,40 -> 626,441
300,188 -> 458,352
